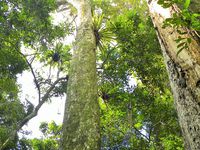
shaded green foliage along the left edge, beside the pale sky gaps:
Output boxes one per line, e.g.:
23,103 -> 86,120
0,0 -> 67,149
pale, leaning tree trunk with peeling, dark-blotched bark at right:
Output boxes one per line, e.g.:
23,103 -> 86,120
148,0 -> 200,150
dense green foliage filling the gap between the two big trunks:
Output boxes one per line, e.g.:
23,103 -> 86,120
97,7 -> 183,149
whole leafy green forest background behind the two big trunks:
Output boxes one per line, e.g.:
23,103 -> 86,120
0,0 -> 200,150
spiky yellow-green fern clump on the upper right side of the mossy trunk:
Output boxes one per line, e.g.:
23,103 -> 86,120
93,14 -> 115,51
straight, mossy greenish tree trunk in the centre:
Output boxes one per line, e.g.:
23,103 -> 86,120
61,0 -> 100,150
